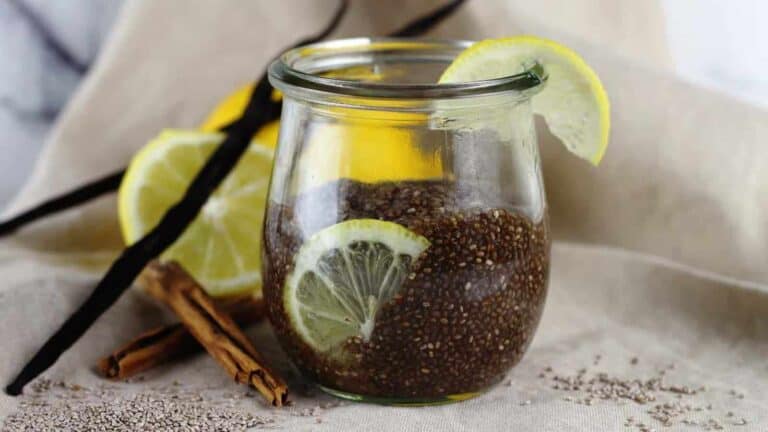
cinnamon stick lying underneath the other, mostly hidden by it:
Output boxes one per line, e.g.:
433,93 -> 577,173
97,297 -> 264,379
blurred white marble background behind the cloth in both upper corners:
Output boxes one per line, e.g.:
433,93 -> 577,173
0,0 -> 768,209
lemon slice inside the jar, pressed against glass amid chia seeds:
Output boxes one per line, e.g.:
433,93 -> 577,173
283,219 -> 429,352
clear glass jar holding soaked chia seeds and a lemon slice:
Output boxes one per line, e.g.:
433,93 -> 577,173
262,38 -> 550,404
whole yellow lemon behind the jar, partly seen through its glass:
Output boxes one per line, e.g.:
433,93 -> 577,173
202,82 -> 443,189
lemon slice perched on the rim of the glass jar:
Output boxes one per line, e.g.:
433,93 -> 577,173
440,36 -> 611,165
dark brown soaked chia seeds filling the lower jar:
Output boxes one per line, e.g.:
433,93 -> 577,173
263,180 -> 550,401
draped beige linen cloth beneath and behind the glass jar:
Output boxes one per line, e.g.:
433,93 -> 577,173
0,0 -> 768,431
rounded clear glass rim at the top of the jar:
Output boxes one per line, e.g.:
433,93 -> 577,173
269,37 -> 547,100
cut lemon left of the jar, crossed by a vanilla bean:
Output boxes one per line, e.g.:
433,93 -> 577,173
118,130 -> 273,297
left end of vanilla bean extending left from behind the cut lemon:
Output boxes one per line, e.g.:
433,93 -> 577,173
0,169 -> 125,237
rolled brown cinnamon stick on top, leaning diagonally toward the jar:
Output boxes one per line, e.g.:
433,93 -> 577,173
146,261 -> 288,407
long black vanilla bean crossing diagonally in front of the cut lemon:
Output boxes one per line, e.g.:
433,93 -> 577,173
5,1 -> 347,396
